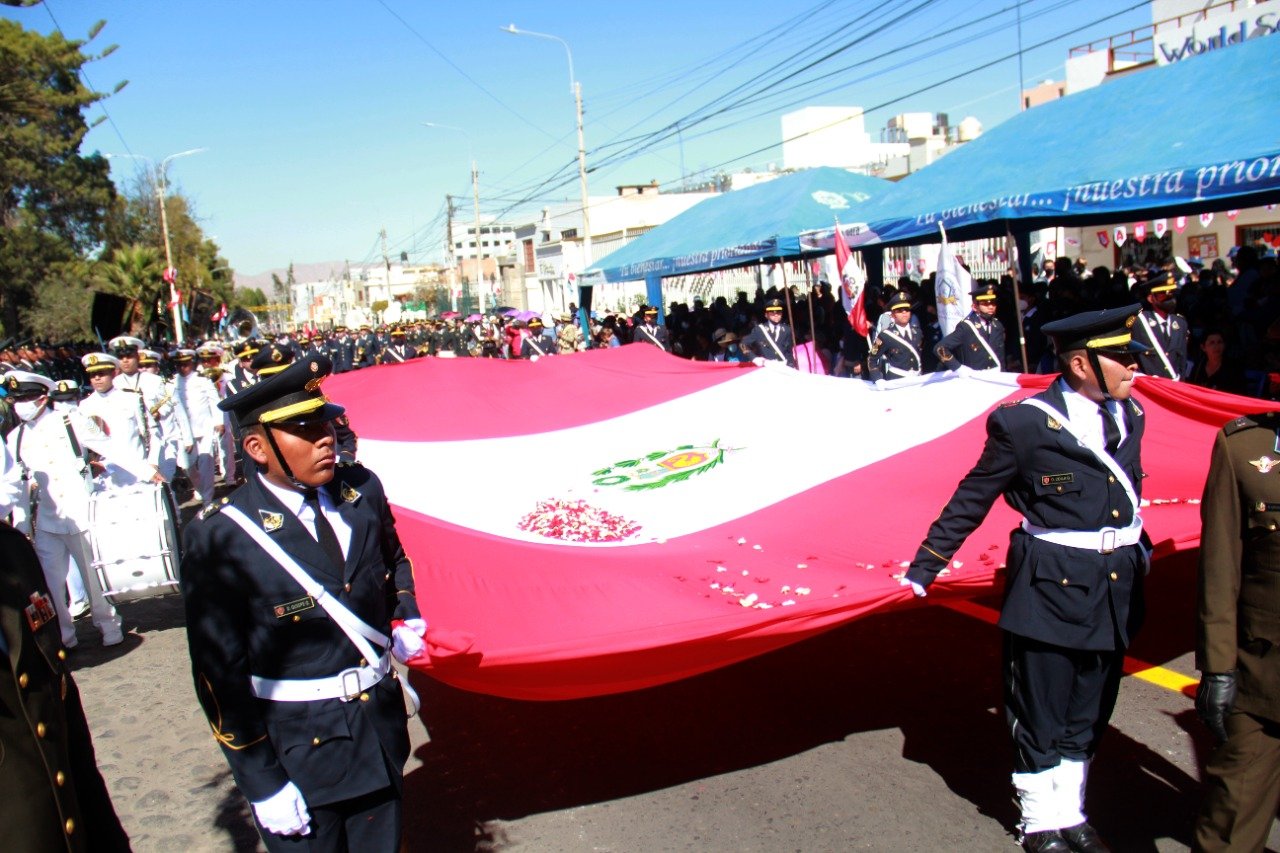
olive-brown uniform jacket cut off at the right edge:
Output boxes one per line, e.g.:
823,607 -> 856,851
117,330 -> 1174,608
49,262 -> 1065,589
1196,412 -> 1280,721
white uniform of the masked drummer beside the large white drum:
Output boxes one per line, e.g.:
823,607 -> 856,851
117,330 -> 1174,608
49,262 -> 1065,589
5,406 -> 155,646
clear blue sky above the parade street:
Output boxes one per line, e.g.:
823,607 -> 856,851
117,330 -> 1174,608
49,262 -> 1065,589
0,0 -> 1151,277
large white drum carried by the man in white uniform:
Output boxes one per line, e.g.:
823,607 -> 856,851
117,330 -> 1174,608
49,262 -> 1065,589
88,483 -> 180,603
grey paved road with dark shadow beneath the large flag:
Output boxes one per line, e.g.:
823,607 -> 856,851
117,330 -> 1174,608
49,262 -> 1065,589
73,548 -> 1280,853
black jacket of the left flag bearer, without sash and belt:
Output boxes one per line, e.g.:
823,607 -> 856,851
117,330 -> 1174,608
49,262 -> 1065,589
182,465 -> 419,804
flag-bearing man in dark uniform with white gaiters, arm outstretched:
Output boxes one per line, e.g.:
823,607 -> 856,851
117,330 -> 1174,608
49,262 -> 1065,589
902,305 -> 1149,853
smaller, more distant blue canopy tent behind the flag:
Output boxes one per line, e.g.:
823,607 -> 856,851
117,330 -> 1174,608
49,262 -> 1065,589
579,167 -> 893,315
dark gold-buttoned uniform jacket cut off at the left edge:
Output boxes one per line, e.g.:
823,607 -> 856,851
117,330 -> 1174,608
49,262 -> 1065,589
0,524 -> 129,853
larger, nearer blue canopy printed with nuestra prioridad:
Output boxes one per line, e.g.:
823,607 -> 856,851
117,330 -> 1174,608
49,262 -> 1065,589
850,37 -> 1280,252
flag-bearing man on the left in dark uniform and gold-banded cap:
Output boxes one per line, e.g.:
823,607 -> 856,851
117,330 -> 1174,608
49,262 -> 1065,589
182,356 -> 463,852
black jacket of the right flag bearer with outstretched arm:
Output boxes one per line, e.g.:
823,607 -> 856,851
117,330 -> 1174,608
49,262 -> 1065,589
906,382 -> 1147,651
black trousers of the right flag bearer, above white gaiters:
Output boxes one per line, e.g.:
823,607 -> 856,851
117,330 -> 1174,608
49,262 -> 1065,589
1004,631 -> 1124,774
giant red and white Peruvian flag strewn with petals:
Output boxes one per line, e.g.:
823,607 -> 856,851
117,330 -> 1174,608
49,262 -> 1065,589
325,346 -> 1266,699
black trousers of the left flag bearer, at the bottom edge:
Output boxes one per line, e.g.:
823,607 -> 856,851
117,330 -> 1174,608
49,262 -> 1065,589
253,785 -> 402,853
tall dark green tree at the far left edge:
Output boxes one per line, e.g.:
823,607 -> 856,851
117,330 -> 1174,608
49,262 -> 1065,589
0,20 -> 119,334
